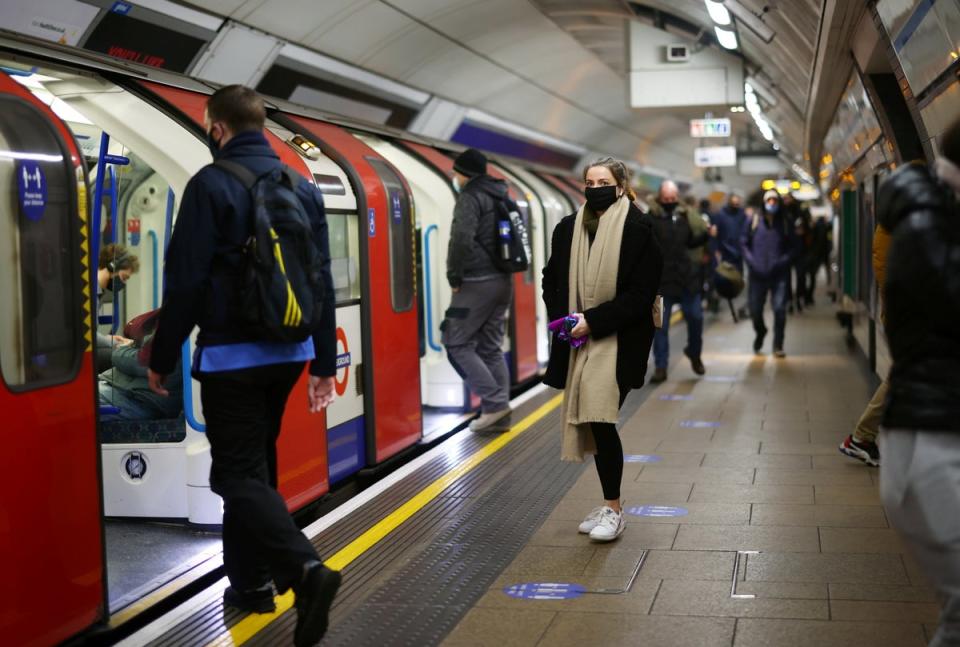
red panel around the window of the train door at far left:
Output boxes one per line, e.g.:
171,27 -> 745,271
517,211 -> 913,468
0,73 -> 105,645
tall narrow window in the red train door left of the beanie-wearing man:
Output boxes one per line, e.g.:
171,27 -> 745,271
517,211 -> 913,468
367,158 -> 415,312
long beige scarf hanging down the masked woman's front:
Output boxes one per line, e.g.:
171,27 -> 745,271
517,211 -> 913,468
561,197 -> 630,462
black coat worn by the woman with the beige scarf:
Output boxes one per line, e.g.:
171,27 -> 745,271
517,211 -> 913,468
543,204 -> 663,393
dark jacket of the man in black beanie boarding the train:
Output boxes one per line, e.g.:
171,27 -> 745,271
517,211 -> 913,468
447,175 -> 508,288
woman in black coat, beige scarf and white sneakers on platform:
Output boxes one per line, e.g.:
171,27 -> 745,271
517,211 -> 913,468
543,157 -> 663,541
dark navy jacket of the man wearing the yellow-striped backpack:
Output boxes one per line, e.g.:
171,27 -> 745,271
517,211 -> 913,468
150,131 -> 336,377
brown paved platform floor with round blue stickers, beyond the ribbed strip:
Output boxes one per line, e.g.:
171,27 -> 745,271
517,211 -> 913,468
443,306 -> 939,647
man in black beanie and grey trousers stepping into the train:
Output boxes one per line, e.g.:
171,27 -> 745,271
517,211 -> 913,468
440,148 -> 513,431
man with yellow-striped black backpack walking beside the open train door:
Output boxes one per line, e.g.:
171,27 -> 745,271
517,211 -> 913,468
148,85 -> 340,646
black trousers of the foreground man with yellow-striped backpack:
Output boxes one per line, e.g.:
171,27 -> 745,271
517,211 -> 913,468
200,362 -> 319,593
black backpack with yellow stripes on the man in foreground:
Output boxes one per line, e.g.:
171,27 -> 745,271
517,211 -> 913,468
214,160 -> 324,342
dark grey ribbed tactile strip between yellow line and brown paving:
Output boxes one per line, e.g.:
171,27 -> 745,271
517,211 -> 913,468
250,404 -> 584,646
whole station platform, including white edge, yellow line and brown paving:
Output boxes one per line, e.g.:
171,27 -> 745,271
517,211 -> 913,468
122,305 -> 939,647
